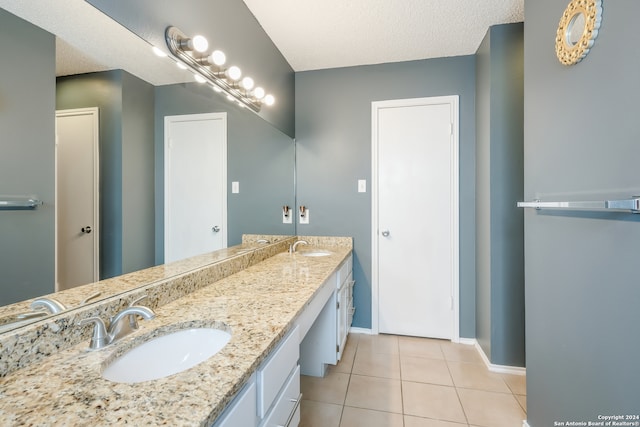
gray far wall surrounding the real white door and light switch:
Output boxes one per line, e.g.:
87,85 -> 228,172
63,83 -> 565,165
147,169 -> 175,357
296,56 -> 475,337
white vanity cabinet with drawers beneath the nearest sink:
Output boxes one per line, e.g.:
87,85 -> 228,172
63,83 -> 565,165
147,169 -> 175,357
212,327 -> 301,427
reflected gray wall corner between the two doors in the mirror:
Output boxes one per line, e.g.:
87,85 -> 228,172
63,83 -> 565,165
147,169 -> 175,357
56,70 -> 154,279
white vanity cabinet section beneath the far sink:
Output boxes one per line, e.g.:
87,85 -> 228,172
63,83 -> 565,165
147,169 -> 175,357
300,255 -> 354,377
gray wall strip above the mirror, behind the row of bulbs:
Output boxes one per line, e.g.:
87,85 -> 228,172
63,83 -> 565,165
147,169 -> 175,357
88,0 -> 295,137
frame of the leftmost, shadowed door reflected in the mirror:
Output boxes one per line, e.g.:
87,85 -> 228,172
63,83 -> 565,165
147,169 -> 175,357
54,107 -> 100,292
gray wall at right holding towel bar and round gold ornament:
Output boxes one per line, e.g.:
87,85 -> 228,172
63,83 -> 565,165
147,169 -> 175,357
524,0 -> 640,427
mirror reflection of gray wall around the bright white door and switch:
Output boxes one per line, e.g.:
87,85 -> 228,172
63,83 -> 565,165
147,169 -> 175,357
155,83 -> 295,263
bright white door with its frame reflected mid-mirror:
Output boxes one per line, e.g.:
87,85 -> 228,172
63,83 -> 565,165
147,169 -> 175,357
164,113 -> 227,262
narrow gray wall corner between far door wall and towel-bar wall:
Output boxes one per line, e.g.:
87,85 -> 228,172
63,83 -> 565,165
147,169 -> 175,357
476,23 -> 525,366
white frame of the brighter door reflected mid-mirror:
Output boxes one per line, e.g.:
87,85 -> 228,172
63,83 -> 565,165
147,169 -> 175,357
162,112 -> 229,260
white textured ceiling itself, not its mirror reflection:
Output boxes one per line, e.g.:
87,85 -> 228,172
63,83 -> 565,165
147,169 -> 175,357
243,0 -> 524,71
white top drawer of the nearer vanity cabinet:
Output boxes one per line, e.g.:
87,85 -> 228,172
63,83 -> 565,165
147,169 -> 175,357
257,327 -> 300,418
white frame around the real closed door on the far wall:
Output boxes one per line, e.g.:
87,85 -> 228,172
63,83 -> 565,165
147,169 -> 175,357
371,95 -> 460,342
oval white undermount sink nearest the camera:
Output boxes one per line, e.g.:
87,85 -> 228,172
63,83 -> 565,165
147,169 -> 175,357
102,328 -> 231,383
